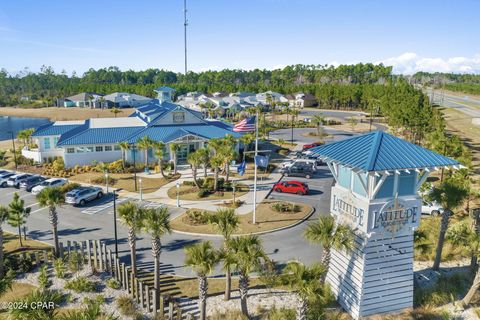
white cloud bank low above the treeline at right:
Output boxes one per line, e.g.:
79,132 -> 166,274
377,52 -> 480,74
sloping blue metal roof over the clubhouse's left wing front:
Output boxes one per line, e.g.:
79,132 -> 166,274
58,127 -> 143,146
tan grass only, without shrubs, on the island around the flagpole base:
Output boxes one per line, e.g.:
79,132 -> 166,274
171,201 -> 312,234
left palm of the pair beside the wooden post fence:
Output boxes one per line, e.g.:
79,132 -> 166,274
118,201 -> 143,277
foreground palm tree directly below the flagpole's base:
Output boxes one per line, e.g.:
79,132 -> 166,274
229,235 -> 268,317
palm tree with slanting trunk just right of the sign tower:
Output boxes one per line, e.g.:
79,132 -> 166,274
428,178 -> 468,271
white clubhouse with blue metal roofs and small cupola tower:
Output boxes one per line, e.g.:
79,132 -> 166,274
22,87 -> 241,167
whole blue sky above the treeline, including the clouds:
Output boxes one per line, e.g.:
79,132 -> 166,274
0,0 -> 480,74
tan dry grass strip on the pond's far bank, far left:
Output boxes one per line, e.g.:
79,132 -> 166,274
0,107 -> 133,121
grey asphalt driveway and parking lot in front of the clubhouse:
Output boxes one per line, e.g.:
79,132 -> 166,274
0,174 -> 332,276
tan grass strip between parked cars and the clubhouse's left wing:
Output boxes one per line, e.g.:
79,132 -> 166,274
69,172 -> 180,193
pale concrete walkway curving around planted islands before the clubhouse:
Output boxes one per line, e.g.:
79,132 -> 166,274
119,166 -> 282,215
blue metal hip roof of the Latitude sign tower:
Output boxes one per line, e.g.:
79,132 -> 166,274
311,131 -> 459,171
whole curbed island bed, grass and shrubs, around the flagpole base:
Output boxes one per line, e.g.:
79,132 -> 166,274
171,201 -> 313,234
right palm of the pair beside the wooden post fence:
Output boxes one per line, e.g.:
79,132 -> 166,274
141,207 -> 172,301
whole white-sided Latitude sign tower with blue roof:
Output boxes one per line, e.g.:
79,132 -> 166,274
312,131 -> 460,319
